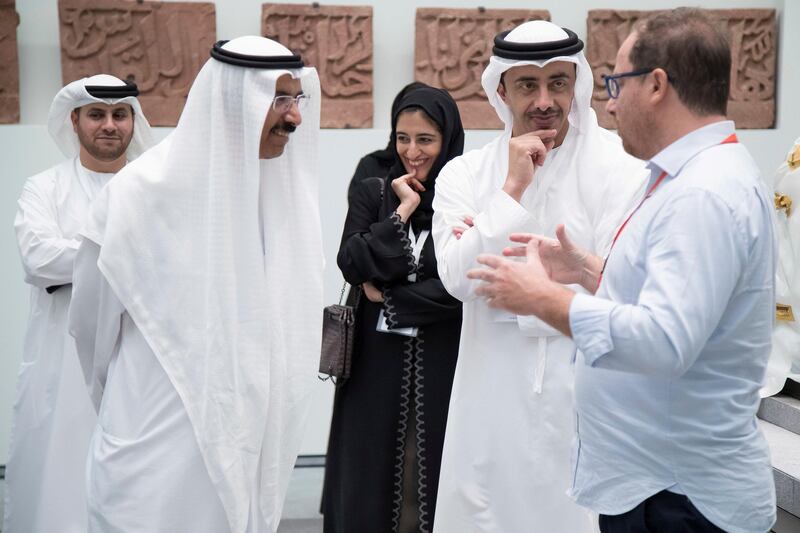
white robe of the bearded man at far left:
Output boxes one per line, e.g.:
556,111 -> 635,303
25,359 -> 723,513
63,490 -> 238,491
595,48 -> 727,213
3,158 -> 113,533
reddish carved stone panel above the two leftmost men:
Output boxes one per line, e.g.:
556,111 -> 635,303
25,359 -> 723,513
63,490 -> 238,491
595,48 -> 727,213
58,0 -> 216,126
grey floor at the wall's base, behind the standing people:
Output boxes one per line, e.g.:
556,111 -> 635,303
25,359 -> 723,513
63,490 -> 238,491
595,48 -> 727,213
0,467 -> 325,533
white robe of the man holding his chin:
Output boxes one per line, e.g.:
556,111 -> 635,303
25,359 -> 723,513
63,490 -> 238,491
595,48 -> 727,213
433,131 -> 646,533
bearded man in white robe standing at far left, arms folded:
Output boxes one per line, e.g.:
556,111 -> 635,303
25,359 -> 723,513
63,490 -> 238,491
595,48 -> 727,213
2,74 -> 152,533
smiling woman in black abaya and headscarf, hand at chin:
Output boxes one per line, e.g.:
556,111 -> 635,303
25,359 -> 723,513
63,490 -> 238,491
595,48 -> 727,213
323,86 -> 464,533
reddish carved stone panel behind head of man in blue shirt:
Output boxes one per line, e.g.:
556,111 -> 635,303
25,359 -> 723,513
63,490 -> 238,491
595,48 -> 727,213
586,9 -> 777,128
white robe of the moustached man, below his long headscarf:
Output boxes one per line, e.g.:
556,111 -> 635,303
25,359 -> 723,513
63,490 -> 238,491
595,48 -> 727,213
70,239 -> 271,533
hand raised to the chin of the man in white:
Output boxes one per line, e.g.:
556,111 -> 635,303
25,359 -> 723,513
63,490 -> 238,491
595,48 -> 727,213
503,130 -> 557,202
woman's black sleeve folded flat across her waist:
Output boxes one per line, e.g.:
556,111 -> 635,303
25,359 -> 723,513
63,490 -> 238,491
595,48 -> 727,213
383,278 -> 461,328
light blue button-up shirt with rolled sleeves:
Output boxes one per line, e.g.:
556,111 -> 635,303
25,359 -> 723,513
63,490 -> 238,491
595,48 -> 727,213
570,121 -> 776,532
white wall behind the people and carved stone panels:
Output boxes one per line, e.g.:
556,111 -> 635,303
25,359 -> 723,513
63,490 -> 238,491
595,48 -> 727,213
0,0 -> 800,463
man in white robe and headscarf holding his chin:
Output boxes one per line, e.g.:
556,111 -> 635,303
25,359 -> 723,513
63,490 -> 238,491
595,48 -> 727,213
433,21 -> 646,533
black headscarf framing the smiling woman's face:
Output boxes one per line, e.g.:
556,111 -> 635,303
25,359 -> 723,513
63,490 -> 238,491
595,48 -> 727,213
387,85 -> 464,230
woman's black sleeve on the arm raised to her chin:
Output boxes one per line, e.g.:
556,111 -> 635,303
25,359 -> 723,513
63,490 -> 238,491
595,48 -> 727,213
336,179 -> 414,288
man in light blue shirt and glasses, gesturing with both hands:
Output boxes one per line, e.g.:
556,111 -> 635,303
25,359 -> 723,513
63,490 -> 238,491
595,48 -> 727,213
469,9 -> 776,533
